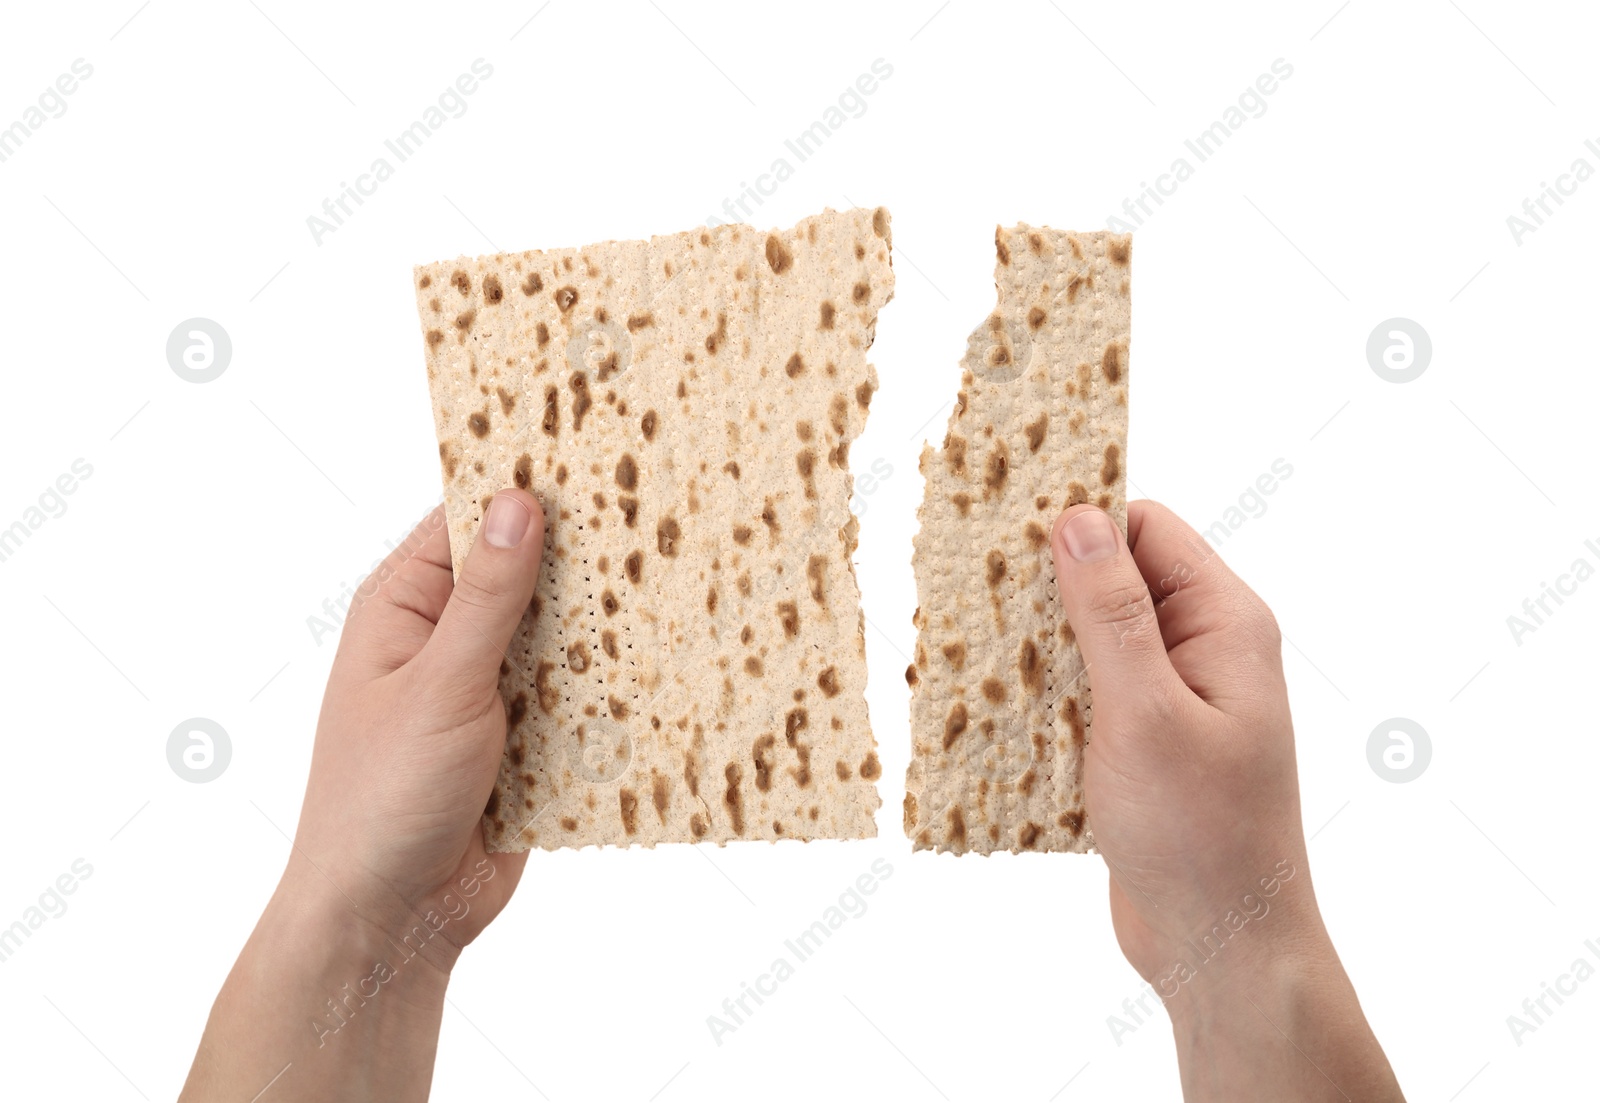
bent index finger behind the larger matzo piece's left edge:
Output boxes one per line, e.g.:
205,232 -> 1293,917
337,506 -> 450,680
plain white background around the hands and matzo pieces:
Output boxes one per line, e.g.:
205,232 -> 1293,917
0,0 -> 1600,1103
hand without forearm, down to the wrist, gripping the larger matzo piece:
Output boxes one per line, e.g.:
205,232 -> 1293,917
294,490 -> 544,972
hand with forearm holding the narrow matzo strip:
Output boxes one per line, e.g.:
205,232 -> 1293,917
1051,501 -> 1402,1100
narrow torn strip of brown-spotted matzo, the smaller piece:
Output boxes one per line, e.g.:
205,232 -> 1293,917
906,226 -> 1133,853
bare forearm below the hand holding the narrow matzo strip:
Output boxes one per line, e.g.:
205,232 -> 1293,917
1168,932 -> 1403,1103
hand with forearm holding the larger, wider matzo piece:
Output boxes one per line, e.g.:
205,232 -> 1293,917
181,490 -> 544,1100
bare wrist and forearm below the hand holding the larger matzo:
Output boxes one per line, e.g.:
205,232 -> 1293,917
181,863 -> 448,1103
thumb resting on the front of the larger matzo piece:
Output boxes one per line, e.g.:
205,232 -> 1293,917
424,490 -> 544,693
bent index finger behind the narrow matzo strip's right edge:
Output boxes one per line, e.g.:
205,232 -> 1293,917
1128,501 -> 1282,712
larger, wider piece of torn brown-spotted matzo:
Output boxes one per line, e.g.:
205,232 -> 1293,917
416,208 -> 894,850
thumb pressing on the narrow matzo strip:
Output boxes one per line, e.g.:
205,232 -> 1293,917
1050,506 -> 1179,703
